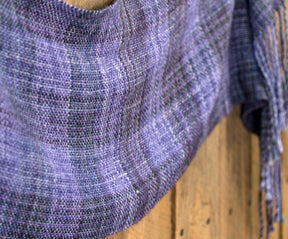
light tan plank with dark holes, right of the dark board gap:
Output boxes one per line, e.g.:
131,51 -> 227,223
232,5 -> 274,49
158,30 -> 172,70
175,109 -> 226,239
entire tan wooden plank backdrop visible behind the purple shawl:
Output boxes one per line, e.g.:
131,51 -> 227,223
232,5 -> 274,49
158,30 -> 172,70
60,0 -> 288,239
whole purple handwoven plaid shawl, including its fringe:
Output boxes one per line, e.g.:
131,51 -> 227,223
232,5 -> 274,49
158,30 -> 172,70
0,0 -> 288,239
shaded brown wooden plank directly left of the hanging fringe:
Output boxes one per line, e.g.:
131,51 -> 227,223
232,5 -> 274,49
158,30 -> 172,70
219,106 -> 251,238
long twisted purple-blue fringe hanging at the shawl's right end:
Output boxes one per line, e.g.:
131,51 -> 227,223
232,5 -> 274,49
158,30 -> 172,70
254,0 -> 288,239
